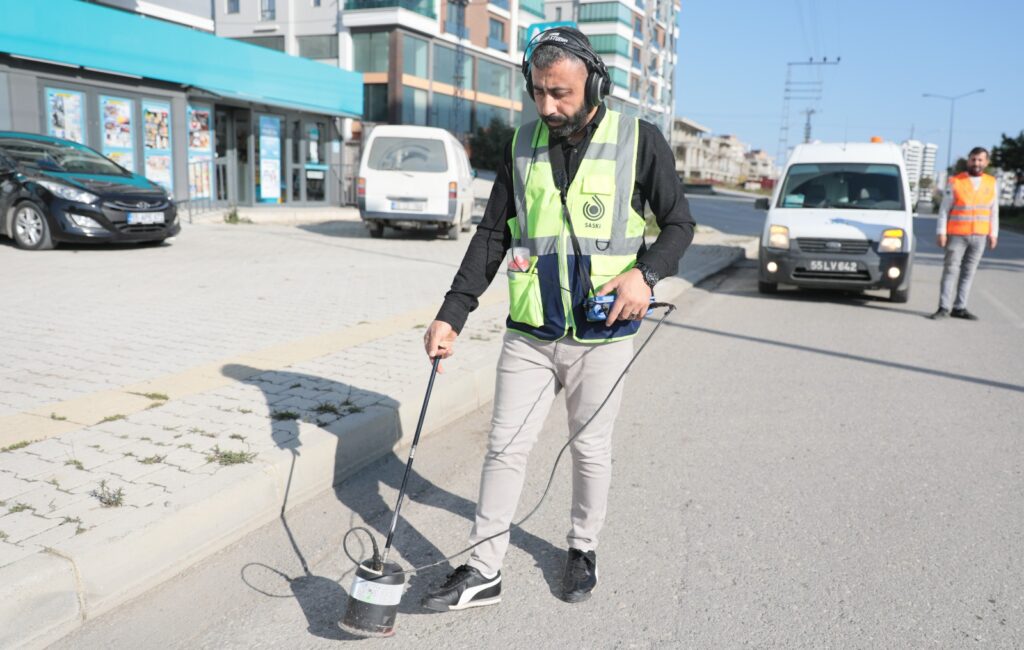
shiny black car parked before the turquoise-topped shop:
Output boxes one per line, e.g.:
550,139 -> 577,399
0,131 -> 181,250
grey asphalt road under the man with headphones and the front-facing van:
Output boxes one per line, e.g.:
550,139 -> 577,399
55,223 -> 1024,649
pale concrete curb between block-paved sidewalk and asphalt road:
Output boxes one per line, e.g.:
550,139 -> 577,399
19,235 -> 757,647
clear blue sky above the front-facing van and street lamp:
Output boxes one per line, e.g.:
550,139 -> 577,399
675,0 -> 1024,167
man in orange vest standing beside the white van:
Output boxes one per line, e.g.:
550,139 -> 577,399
929,146 -> 999,320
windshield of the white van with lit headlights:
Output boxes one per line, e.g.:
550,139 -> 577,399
775,163 -> 903,210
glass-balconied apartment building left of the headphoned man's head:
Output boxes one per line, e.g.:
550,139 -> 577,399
214,0 -> 544,135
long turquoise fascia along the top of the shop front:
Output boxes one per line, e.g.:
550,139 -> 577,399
0,0 -> 362,118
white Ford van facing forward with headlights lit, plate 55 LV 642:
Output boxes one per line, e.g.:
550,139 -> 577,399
756,138 -> 915,302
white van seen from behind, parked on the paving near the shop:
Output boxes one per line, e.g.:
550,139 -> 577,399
356,125 -> 473,240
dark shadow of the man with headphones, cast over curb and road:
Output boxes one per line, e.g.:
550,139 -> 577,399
222,364 -> 564,640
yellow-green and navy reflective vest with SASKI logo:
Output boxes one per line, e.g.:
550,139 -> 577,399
508,111 -> 645,343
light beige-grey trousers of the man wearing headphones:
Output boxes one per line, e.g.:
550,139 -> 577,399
468,332 -> 633,575
